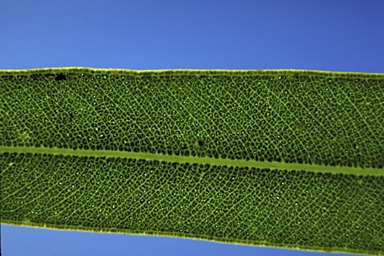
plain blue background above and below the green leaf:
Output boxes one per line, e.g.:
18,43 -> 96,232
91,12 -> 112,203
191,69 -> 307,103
0,0 -> 384,256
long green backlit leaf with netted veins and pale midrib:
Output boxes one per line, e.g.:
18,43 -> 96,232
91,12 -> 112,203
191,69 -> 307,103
0,68 -> 384,254
